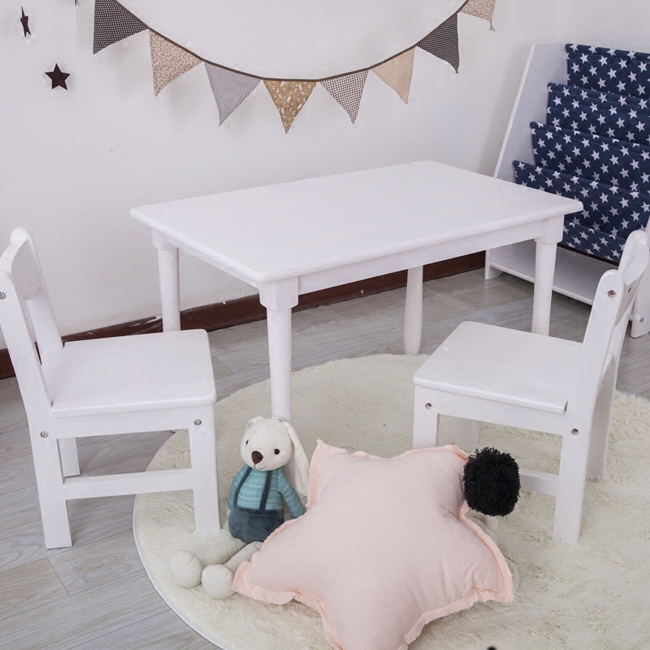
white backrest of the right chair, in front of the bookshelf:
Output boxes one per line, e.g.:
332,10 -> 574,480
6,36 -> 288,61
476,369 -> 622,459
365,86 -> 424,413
569,230 -> 650,404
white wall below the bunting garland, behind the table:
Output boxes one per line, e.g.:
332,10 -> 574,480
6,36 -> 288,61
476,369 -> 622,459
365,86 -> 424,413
0,0 -> 576,344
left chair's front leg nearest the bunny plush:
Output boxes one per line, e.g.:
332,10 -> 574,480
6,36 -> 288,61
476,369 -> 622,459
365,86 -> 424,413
189,407 -> 220,533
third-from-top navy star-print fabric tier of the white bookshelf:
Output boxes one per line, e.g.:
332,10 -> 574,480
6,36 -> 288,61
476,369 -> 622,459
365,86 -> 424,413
530,122 -> 650,194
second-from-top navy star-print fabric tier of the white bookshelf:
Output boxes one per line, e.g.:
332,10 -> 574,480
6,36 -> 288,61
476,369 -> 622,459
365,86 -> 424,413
546,84 -> 650,145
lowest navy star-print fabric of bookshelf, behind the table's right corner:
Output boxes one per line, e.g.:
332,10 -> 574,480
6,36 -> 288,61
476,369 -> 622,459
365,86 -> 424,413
513,161 -> 650,263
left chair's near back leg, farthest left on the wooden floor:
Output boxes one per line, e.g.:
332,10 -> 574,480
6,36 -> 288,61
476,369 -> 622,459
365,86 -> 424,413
32,434 -> 72,548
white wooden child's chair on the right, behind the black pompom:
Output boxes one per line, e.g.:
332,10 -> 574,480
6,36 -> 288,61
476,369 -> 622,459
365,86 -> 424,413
413,231 -> 649,543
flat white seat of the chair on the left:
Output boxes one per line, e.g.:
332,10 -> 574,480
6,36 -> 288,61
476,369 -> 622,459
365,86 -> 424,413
42,330 -> 216,418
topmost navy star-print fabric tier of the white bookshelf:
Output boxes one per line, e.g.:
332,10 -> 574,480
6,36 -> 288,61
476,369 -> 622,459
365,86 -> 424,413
566,44 -> 650,97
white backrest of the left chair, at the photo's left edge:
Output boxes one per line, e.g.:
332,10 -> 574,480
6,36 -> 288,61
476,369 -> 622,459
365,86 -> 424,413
0,228 -> 63,419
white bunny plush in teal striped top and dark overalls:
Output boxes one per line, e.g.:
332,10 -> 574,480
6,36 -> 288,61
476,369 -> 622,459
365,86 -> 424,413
169,416 -> 309,598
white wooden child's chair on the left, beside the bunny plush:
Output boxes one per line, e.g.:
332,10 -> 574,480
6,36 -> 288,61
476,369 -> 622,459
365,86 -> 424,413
0,228 -> 219,548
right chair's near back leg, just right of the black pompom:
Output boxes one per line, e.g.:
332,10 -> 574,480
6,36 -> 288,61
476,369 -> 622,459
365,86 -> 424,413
553,428 -> 590,544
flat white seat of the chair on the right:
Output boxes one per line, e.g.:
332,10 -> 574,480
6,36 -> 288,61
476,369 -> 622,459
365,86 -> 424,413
414,321 -> 582,413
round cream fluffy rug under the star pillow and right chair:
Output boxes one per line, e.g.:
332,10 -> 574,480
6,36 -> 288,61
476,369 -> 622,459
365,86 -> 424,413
134,355 -> 650,650
